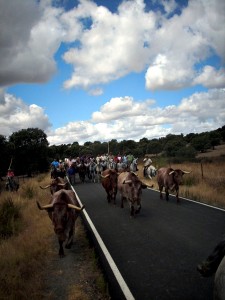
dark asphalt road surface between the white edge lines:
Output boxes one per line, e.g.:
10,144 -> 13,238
75,183 -> 225,300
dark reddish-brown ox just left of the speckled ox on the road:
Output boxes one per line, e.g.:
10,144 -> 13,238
101,169 -> 118,204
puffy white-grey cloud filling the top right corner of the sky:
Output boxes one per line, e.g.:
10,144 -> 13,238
145,0 -> 225,90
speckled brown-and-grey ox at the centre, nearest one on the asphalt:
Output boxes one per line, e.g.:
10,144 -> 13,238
118,172 -> 147,216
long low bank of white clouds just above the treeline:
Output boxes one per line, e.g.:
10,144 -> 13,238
0,89 -> 225,145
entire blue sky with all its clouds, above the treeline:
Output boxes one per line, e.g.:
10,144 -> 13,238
0,0 -> 225,145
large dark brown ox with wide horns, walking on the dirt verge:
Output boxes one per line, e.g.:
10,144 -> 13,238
37,190 -> 84,257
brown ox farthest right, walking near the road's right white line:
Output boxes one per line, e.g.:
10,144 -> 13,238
157,168 -> 190,203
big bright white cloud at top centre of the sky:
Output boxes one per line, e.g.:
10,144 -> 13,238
63,1 -> 156,89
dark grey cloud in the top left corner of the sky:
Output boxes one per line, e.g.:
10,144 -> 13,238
0,0 -> 60,86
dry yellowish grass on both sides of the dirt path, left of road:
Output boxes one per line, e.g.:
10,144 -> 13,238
0,174 -> 110,300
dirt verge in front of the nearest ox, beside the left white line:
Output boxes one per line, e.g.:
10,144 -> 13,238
43,218 -> 111,300
